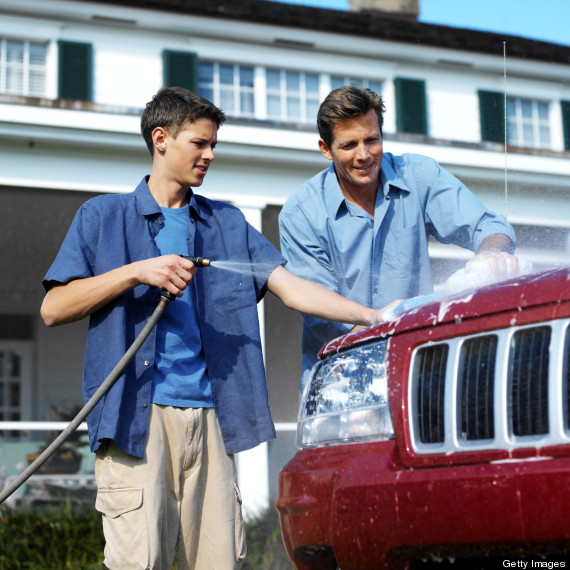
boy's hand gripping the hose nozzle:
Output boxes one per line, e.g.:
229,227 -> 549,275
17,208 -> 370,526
136,255 -> 197,297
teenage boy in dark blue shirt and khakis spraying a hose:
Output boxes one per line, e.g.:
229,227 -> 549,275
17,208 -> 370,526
41,88 -> 384,570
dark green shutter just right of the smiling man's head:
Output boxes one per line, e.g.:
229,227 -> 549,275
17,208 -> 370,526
394,77 -> 427,135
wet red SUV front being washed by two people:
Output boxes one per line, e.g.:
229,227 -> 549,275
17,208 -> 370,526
276,268 -> 570,570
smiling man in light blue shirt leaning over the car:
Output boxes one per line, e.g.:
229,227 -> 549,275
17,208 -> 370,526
279,85 -> 517,387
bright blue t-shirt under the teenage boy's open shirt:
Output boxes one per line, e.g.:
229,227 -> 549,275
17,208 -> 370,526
151,205 -> 214,408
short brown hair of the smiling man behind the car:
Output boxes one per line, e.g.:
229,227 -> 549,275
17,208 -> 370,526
317,85 -> 385,148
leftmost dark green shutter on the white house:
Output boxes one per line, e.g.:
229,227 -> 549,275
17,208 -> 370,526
58,40 -> 93,101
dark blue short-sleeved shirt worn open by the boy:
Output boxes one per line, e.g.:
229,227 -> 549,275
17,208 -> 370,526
43,178 -> 286,457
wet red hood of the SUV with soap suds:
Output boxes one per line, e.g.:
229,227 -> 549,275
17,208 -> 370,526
319,267 -> 570,358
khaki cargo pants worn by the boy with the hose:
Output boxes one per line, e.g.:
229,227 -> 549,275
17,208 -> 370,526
95,404 -> 246,570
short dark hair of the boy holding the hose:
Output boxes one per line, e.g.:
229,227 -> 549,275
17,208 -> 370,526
141,87 -> 226,156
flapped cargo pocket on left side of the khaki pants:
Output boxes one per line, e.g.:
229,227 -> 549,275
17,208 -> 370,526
95,487 -> 150,569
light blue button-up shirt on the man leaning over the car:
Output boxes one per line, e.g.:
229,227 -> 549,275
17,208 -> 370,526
279,153 -> 515,383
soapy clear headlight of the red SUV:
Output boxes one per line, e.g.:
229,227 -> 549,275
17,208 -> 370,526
297,341 -> 394,448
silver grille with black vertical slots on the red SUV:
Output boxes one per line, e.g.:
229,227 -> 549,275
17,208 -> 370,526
408,319 -> 570,453
